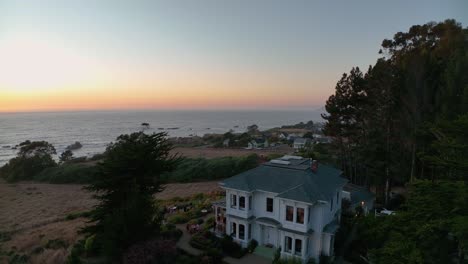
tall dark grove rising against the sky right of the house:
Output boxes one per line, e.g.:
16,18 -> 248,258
323,20 -> 468,201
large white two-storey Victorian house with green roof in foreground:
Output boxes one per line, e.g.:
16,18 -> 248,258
215,156 -> 347,262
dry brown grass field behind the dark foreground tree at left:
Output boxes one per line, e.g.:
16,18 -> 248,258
0,182 -> 219,263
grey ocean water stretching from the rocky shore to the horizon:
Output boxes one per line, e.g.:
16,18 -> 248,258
0,110 -> 321,166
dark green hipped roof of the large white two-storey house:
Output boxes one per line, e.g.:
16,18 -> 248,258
221,159 -> 347,203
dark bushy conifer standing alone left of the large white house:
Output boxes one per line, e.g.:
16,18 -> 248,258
84,132 -> 179,260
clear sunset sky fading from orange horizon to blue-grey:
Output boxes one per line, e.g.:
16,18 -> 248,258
0,0 -> 468,112
